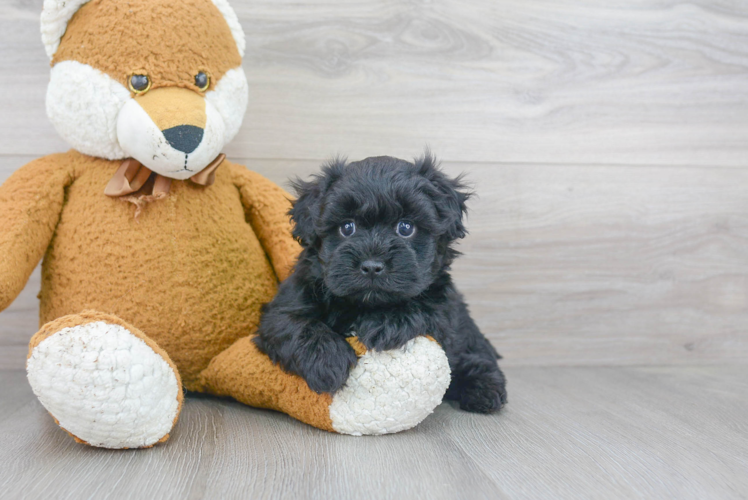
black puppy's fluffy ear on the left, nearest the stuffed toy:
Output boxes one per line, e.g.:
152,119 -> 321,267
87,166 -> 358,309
288,158 -> 346,248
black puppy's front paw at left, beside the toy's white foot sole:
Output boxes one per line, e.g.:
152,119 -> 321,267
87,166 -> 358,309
298,336 -> 358,393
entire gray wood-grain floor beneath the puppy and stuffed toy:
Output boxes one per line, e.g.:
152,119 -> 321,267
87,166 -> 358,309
0,366 -> 748,499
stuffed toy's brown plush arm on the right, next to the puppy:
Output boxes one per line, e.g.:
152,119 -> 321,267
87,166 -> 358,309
225,161 -> 301,281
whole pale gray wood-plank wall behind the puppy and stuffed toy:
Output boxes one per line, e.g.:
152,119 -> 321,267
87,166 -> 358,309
0,0 -> 748,367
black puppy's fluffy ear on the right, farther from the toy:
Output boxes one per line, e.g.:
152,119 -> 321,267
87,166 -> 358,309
415,151 -> 472,240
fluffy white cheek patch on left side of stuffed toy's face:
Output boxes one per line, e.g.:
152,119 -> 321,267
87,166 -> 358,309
47,61 -> 130,160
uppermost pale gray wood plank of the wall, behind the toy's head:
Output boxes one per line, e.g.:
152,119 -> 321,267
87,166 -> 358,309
0,0 -> 748,166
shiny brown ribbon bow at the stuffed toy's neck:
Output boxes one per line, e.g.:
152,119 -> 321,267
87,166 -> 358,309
104,153 -> 226,218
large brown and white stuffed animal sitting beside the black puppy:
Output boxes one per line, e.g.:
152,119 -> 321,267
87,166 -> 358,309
0,0 -> 449,448
